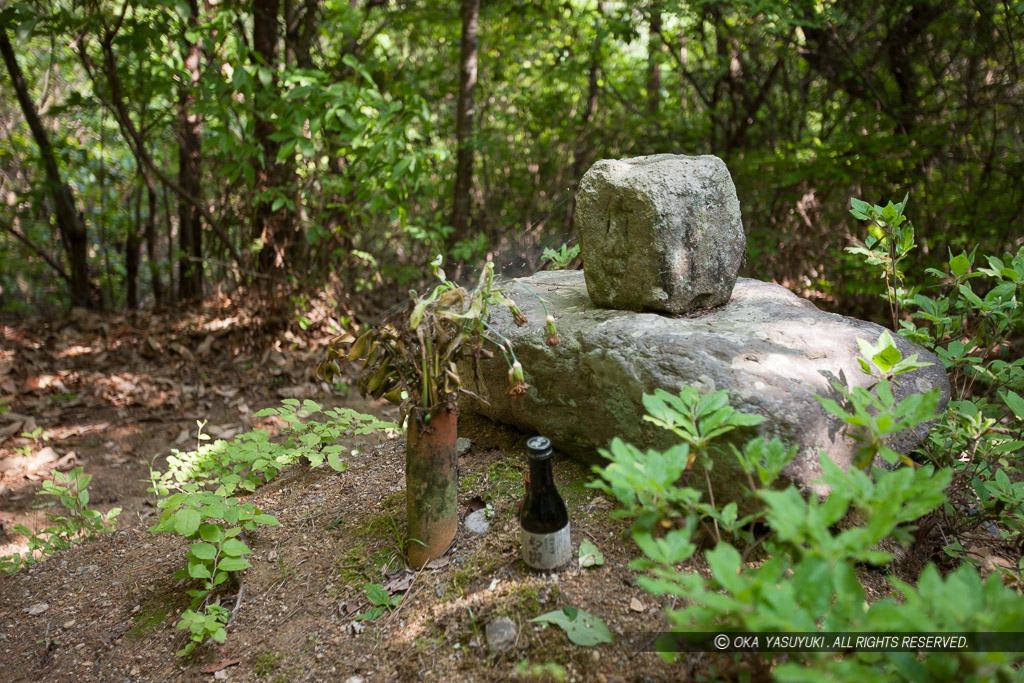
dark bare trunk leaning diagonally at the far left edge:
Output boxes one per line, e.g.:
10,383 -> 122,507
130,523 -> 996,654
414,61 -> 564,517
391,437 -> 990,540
0,30 -> 95,307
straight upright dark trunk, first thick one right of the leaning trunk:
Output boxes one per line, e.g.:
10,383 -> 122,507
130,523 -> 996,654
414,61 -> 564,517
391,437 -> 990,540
178,0 -> 203,300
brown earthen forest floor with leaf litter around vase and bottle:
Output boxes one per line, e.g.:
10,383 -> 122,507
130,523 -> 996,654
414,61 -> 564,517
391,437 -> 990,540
0,301 -> 724,683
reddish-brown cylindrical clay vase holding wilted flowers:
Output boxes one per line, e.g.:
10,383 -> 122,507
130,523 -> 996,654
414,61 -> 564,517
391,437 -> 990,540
406,405 -> 459,569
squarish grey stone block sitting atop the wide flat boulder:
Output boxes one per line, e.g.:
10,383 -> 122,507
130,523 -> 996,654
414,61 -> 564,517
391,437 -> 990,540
574,155 -> 746,313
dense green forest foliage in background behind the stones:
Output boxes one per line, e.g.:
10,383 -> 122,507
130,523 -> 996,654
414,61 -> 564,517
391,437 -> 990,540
0,2 -> 1024,312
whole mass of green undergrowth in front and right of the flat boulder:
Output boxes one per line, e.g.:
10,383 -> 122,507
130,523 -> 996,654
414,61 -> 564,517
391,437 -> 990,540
593,194 -> 1024,681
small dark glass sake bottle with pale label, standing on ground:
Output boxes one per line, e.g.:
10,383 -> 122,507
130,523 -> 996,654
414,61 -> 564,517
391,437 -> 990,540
519,436 -> 572,569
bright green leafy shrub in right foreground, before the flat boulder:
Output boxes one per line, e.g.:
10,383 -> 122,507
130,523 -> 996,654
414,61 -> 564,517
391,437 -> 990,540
594,338 -> 1024,681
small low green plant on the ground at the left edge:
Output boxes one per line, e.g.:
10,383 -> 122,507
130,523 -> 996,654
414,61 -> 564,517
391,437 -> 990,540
0,467 -> 121,573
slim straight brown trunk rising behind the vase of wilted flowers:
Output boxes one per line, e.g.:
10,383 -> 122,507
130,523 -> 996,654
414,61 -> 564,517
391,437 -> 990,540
452,0 -> 480,241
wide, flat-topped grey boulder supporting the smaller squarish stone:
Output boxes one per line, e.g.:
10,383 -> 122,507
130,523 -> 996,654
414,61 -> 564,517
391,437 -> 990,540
462,270 -> 949,503
